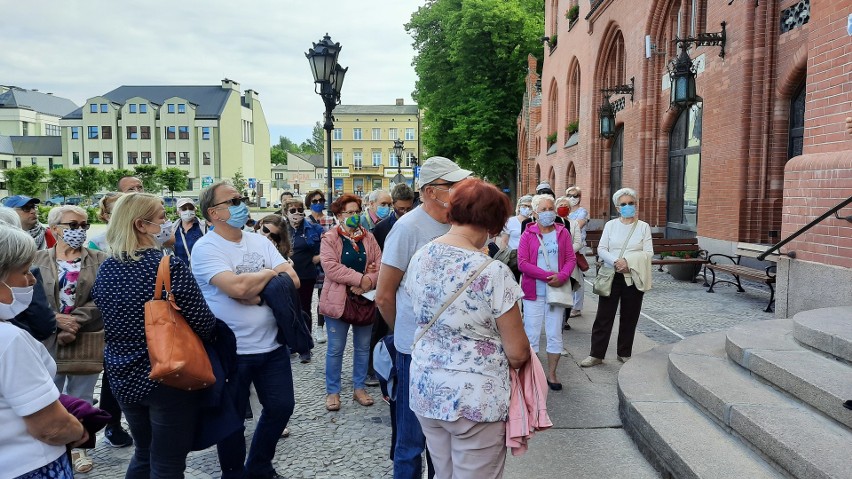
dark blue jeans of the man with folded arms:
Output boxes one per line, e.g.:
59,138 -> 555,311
216,346 -> 296,479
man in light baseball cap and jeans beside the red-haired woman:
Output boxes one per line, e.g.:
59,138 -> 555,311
376,156 -> 471,479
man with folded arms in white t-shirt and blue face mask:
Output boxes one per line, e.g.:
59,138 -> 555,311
192,182 -> 299,479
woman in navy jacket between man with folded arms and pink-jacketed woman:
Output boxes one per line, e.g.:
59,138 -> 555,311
283,199 -> 323,364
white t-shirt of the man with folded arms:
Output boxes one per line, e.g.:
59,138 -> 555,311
191,230 -> 285,354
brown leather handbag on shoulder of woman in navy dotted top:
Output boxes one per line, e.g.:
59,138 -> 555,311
145,256 -> 216,391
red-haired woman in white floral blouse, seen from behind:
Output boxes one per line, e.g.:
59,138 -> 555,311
403,178 -> 530,478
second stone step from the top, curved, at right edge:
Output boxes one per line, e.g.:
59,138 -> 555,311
726,319 -> 852,428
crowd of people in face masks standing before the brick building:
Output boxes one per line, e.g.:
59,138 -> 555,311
0,157 -> 652,479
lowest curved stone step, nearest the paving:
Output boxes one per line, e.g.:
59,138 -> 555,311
618,345 -> 785,479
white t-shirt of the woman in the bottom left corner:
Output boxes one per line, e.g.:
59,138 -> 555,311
0,321 -> 65,477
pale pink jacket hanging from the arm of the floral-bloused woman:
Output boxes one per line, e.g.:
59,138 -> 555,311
506,348 -> 553,456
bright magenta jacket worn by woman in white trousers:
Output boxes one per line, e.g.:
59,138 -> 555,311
518,223 -> 577,301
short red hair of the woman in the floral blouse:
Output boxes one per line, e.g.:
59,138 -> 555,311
447,178 -> 512,235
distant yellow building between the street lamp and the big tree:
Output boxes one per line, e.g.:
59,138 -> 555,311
322,99 -> 421,196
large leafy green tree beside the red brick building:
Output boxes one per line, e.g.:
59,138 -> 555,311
405,0 -> 544,191
